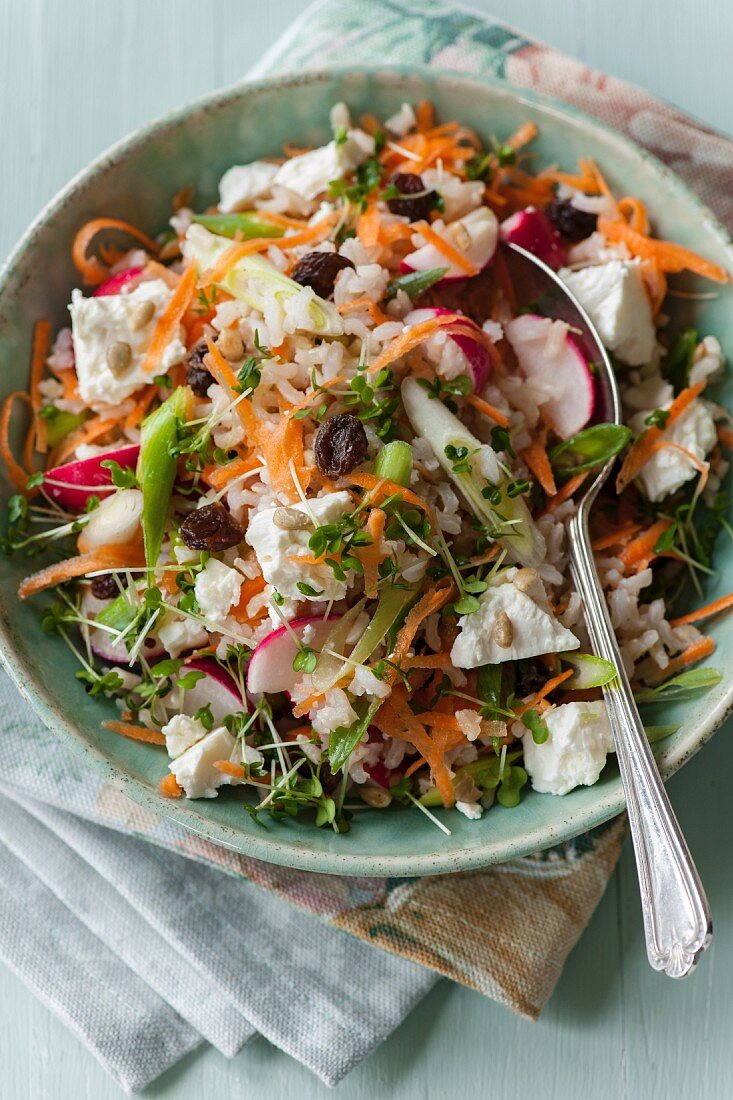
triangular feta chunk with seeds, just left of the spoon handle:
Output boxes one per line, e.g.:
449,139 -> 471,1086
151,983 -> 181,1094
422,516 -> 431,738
450,569 -> 580,669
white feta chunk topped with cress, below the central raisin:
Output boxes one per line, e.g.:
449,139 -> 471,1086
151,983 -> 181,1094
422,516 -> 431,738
244,492 -> 353,601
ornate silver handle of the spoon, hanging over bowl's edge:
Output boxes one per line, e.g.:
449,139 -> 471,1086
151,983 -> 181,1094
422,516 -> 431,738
568,501 -> 712,978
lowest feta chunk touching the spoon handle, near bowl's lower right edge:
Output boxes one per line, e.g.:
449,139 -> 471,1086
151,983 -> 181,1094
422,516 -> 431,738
522,702 -> 613,794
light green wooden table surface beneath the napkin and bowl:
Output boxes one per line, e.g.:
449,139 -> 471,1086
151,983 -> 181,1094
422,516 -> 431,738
0,0 -> 733,1100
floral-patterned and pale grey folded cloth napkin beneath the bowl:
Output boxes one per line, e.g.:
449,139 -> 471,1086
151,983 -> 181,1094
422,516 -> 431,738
0,0 -> 733,1090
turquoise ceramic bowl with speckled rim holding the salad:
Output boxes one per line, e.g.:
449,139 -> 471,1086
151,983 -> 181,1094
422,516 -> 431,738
0,69 -> 733,876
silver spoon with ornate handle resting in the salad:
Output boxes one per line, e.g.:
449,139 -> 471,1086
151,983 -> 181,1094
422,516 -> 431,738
503,244 -> 712,978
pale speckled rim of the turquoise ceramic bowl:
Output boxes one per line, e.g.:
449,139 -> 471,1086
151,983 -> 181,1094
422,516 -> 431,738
0,65 -> 733,878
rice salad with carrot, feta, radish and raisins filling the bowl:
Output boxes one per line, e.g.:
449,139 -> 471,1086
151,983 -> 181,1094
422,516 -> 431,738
0,102 -> 733,833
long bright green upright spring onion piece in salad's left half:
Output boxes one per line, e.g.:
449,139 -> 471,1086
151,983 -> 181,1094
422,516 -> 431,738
138,386 -> 190,569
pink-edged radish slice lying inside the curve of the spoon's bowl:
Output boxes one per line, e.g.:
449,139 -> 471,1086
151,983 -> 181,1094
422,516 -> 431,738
505,314 -> 595,439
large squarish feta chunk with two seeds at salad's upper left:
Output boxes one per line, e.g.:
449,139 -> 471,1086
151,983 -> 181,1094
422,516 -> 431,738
68,279 -> 186,405
